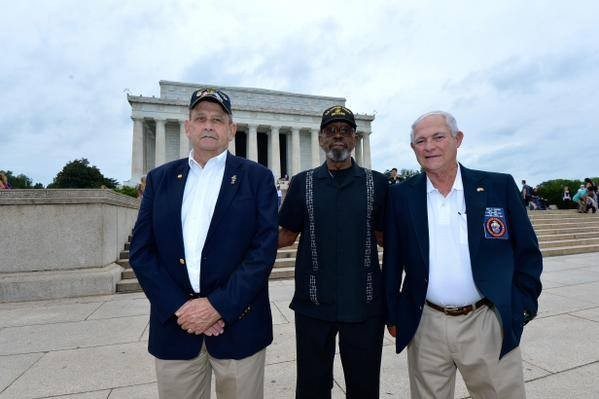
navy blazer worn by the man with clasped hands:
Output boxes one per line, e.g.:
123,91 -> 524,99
129,153 -> 278,359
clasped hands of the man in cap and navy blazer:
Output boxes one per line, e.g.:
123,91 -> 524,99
175,298 -> 225,336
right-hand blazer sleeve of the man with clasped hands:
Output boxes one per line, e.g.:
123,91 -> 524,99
208,170 -> 279,324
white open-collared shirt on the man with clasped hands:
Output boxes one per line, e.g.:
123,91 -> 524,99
181,150 -> 227,293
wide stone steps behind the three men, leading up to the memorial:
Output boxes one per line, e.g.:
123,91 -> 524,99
116,210 -> 599,293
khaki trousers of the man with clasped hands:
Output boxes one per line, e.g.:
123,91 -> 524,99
155,344 -> 266,399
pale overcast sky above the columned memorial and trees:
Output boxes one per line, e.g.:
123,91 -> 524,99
0,0 -> 599,185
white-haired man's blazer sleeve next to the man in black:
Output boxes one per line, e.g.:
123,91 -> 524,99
383,187 -> 403,326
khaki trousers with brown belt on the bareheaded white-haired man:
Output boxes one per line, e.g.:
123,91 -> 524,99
408,305 -> 526,399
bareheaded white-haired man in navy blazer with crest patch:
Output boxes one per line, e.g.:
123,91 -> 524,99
383,111 -> 542,398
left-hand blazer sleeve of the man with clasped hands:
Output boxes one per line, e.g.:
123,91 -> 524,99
129,172 -> 187,323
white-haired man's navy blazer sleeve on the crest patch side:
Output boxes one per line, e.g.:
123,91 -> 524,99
507,176 -> 543,318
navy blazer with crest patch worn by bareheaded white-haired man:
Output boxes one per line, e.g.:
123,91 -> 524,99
383,165 -> 543,357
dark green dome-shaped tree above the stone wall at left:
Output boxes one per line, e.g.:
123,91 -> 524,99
48,158 -> 118,188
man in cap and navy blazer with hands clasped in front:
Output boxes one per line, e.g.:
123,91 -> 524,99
130,89 -> 278,399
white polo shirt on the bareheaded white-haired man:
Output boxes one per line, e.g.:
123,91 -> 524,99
426,165 -> 482,306
